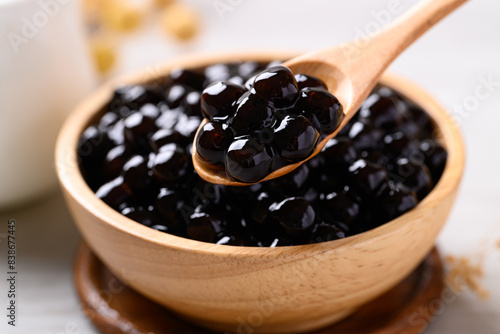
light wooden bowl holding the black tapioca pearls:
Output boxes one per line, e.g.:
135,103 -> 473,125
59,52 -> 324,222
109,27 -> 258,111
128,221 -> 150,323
56,52 -> 464,333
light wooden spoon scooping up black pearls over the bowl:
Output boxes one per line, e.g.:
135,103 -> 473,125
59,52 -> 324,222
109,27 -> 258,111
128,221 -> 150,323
193,0 -> 467,186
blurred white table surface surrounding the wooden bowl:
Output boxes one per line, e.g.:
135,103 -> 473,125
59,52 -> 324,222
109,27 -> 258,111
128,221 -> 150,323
0,0 -> 500,334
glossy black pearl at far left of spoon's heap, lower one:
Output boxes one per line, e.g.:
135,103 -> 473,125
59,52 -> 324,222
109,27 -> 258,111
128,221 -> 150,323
196,122 -> 233,164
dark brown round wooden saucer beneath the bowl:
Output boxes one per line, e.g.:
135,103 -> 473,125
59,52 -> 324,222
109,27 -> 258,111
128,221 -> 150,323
74,244 -> 444,334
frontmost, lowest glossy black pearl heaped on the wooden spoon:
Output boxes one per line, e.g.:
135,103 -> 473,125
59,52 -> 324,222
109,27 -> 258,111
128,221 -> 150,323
226,137 -> 273,183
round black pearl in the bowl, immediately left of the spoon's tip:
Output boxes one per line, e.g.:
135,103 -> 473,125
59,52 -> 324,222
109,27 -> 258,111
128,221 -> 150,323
151,144 -> 190,181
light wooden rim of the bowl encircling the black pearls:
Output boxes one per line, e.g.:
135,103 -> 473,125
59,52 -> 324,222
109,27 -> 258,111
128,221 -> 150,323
55,51 -> 465,258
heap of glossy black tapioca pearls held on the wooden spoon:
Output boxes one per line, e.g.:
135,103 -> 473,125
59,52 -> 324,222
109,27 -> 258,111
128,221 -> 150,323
196,66 -> 344,183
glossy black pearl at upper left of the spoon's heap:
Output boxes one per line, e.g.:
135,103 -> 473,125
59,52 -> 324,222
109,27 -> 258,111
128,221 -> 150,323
201,81 -> 245,120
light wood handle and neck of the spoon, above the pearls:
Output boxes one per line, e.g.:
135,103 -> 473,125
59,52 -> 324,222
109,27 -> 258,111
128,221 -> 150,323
285,0 -> 467,120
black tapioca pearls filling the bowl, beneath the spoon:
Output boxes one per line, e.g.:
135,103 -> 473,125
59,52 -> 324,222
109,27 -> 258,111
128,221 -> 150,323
78,62 -> 447,247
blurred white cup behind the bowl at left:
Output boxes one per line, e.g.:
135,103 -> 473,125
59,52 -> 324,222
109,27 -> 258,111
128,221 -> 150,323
0,0 -> 96,209
